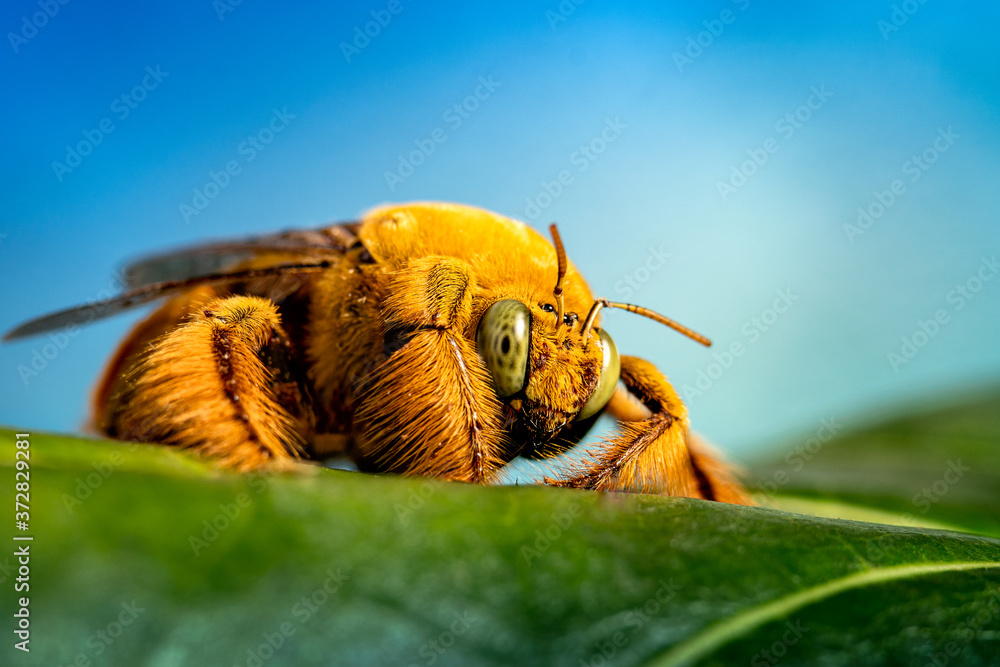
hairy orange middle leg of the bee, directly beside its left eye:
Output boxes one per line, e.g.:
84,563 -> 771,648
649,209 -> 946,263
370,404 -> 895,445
355,257 -> 503,483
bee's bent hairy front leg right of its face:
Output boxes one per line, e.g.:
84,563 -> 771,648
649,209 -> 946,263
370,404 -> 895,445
545,356 -> 752,505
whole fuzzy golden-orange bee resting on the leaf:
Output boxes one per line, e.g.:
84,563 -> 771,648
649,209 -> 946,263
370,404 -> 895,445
5,202 -> 750,504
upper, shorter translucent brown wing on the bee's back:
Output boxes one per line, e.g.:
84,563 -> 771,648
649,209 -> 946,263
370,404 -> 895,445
123,223 -> 360,289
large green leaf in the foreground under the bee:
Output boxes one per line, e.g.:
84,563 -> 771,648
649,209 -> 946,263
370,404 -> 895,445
0,431 -> 1000,667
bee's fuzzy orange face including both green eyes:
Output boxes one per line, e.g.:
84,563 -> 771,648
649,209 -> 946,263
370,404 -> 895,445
476,299 -> 619,443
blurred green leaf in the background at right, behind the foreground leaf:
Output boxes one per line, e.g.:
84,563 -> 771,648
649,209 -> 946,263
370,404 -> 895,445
751,390 -> 1000,536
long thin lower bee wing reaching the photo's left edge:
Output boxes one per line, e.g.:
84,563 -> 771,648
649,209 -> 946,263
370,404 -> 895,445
3,260 -> 333,341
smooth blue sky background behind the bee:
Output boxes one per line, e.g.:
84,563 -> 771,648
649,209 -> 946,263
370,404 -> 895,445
0,0 -> 1000,460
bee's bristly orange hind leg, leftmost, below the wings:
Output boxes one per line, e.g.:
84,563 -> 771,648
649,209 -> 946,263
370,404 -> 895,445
106,296 -> 304,471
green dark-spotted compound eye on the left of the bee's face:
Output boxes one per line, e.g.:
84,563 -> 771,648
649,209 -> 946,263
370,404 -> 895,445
476,299 -> 531,398
